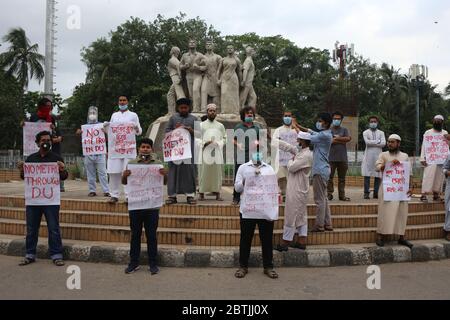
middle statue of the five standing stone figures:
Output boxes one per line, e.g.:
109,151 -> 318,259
202,40 -> 222,112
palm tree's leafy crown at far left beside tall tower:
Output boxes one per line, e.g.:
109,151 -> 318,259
0,28 -> 45,89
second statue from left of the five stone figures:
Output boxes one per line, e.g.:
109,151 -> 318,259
180,39 -> 207,112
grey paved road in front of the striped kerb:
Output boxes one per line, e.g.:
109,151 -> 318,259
0,256 -> 450,300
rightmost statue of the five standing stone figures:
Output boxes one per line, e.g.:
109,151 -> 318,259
240,46 -> 257,108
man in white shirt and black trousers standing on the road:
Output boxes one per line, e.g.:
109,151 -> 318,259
234,152 -> 278,279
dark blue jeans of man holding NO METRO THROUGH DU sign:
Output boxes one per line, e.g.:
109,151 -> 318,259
25,206 -> 63,260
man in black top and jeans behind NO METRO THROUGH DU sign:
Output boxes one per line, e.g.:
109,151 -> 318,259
18,131 -> 68,266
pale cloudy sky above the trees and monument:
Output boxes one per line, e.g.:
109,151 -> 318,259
0,0 -> 450,98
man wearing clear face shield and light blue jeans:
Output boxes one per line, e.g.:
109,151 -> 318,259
76,107 -> 110,197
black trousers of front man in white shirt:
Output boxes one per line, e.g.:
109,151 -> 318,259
239,214 -> 274,269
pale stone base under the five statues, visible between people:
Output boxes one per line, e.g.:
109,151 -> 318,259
145,113 -> 267,153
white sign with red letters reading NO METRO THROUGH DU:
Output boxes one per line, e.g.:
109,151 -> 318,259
23,162 -> 61,206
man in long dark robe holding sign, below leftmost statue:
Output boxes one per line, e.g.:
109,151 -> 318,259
166,98 -> 197,205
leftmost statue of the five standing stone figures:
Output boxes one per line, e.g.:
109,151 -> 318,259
167,47 -> 186,114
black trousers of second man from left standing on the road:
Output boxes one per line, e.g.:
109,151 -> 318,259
129,209 -> 159,266
